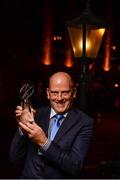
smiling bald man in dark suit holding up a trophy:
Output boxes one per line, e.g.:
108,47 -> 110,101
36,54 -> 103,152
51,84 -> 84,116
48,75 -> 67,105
10,72 -> 93,179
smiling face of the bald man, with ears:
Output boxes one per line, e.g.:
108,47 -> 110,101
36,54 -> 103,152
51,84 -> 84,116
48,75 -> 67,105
47,77 -> 76,113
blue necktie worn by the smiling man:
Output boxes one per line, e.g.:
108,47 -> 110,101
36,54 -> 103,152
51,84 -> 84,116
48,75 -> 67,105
50,114 -> 64,140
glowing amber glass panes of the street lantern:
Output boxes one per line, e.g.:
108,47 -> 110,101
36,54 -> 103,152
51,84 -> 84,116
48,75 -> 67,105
68,24 -> 105,58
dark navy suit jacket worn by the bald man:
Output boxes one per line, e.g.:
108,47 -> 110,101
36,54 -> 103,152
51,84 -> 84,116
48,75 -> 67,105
10,107 -> 93,179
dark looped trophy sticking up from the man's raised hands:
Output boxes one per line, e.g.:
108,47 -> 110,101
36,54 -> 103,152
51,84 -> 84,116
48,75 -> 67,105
19,83 -> 34,111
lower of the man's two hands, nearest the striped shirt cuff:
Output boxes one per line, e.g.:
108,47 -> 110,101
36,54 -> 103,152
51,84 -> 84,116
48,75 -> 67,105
19,121 -> 47,146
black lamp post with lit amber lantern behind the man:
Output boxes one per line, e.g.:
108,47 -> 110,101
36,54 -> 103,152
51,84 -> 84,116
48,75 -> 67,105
66,0 -> 106,111
